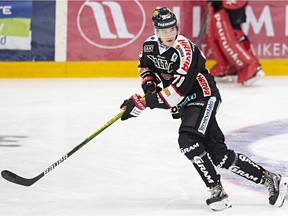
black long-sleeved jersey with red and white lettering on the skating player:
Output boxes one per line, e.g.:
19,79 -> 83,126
138,35 -> 221,109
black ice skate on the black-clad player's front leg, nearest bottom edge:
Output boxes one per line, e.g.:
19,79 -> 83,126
206,182 -> 232,211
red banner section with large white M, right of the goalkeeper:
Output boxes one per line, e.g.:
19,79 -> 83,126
242,0 -> 288,59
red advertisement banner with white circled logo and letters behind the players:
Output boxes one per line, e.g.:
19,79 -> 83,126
67,0 -> 288,61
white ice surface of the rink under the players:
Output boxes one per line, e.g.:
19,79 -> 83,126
0,77 -> 288,216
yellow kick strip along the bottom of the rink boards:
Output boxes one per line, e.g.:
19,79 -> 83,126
0,59 -> 288,78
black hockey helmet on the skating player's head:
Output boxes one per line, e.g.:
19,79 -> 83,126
152,7 -> 178,29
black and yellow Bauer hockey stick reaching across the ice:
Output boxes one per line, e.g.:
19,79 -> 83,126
1,110 -> 125,186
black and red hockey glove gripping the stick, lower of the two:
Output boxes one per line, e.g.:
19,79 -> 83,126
120,94 -> 146,121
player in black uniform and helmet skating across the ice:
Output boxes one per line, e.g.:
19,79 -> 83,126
121,7 -> 287,210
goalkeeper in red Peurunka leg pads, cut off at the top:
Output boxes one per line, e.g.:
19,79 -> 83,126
206,0 -> 264,86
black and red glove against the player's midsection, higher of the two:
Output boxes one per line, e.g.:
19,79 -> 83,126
141,71 -> 161,94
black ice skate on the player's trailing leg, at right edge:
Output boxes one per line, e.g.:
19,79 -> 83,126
263,171 -> 288,207
